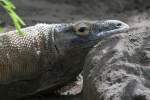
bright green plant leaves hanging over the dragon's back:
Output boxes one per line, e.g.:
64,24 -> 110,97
0,0 -> 25,35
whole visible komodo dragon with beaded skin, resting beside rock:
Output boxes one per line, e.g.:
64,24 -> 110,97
0,20 -> 129,100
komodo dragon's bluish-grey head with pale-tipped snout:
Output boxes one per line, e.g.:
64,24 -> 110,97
50,20 -> 129,54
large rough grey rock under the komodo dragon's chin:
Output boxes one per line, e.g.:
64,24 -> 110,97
83,32 -> 150,100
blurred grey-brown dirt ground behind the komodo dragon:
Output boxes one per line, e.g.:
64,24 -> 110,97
0,0 -> 150,100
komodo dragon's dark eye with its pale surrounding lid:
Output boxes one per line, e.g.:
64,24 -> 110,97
74,23 -> 90,36
